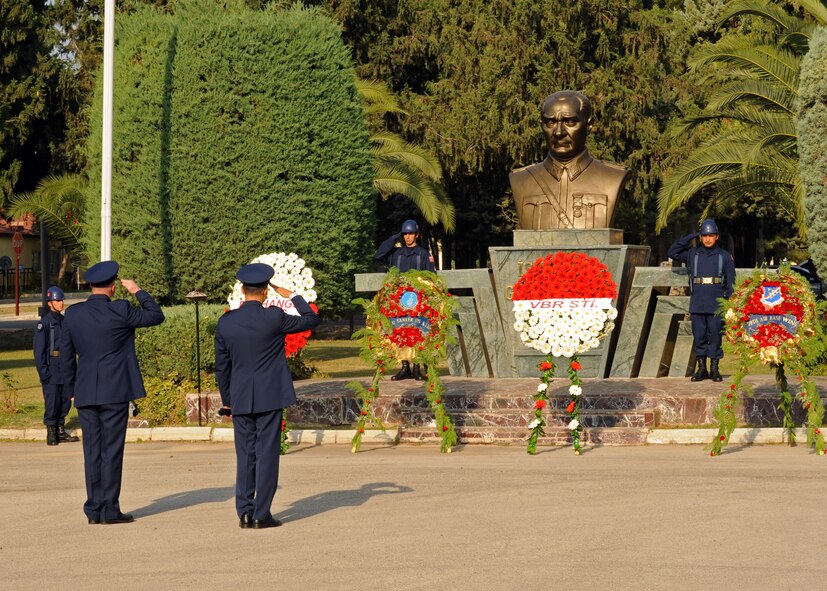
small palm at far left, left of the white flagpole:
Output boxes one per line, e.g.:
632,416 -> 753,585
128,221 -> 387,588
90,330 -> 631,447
9,174 -> 86,277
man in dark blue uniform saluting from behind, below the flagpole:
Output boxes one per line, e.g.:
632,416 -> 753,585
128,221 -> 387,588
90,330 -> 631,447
60,261 -> 164,524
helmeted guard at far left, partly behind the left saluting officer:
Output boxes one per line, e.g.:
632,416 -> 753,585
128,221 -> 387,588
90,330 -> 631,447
34,285 -> 78,445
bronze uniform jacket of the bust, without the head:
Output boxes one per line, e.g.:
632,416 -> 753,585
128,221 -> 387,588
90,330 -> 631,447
508,150 -> 629,230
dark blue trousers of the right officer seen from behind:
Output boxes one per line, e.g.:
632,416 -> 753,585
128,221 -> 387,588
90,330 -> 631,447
233,409 -> 283,520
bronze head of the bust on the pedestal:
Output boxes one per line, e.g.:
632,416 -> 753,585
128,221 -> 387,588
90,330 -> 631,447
541,90 -> 592,162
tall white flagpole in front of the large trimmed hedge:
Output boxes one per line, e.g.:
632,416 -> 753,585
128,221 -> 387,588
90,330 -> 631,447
101,0 -> 115,261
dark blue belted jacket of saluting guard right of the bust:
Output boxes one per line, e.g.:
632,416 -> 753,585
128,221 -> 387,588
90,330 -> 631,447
667,234 -> 735,314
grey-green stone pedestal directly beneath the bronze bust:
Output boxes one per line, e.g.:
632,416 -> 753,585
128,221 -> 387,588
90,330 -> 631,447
488,228 -> 649,378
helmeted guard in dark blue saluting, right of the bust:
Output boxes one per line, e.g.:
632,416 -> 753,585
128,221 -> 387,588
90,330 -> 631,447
667,219 -> 735,382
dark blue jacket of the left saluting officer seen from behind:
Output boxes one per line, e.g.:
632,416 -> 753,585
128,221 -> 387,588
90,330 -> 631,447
60,290 -> 164,408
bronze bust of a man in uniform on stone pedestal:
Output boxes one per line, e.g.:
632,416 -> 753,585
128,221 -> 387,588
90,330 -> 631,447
508,90 -> 629,230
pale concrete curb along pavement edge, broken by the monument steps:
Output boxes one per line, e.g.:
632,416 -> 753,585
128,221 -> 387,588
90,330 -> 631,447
0,427 -> 807,445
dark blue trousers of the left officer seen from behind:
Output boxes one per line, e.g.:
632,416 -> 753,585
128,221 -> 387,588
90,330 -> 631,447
78,402 -> 129,520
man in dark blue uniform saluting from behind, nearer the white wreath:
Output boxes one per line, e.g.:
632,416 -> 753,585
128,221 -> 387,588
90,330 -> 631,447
215,263 -> 320,529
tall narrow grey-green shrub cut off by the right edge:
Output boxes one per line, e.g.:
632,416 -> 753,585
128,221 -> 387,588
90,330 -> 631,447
798,27 -> 827,270
